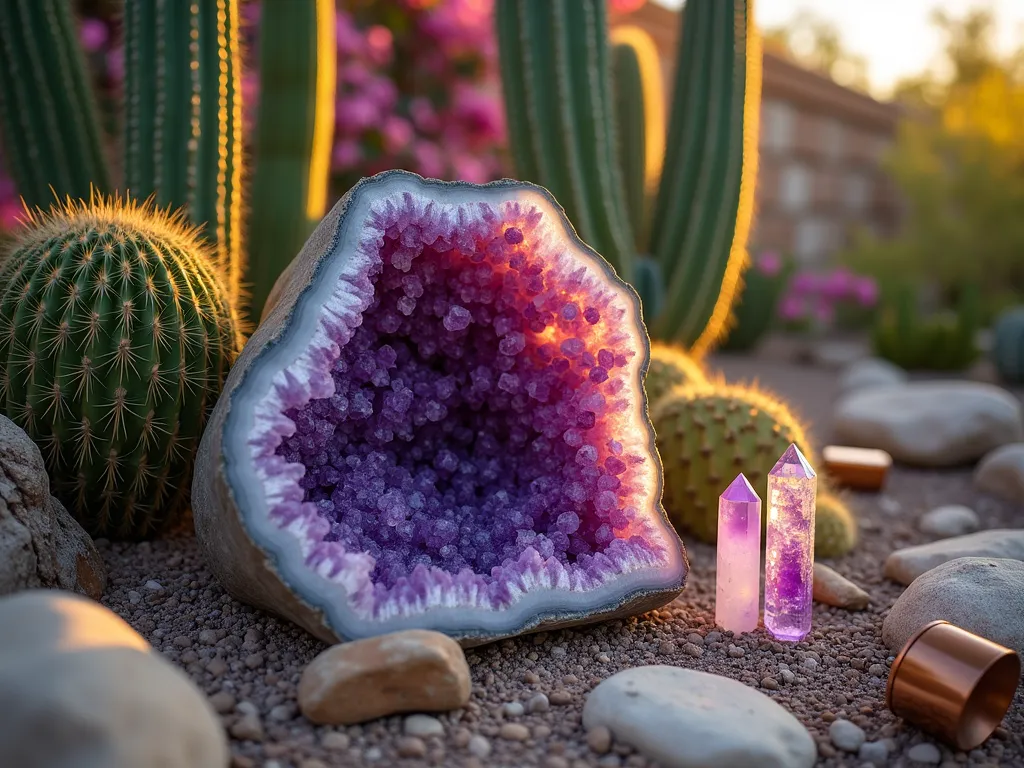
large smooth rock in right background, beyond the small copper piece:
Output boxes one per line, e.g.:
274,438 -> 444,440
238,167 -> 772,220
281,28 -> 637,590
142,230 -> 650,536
835,381 -> 1024,467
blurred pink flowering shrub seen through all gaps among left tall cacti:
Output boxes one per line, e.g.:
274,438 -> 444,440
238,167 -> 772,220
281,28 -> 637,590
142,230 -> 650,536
0,0 -> 505,237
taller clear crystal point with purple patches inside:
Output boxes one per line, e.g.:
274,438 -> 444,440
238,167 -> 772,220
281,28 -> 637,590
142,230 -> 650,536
765,445 -> 818,642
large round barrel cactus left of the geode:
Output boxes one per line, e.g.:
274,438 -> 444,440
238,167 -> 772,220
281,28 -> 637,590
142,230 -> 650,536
0,195 -> 242,538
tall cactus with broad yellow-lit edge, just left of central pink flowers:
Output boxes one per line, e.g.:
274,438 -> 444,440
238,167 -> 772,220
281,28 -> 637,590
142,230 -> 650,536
249,0 -> 337,318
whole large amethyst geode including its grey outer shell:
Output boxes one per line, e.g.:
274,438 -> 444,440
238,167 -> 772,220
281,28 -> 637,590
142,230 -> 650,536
193,171 -> 687,644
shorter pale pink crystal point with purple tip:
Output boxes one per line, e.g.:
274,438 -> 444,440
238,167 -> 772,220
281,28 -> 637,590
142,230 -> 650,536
715,473 -> 761,633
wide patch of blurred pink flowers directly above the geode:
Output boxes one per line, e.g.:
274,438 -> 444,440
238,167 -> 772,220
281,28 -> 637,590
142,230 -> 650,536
332,0 -> 505,194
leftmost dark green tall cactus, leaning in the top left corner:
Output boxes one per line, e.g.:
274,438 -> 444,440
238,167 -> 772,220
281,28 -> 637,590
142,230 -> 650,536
0,0 -> 111,206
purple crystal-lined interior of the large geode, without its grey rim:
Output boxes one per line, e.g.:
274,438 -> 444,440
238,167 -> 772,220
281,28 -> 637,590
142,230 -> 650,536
249,193 -> 679,617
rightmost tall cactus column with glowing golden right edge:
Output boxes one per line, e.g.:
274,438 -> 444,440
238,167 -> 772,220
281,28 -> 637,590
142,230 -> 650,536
651,0 -> 760,355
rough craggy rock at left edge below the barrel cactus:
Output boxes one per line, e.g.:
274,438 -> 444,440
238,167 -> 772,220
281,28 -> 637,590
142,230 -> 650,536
0,416 -> 106,600
